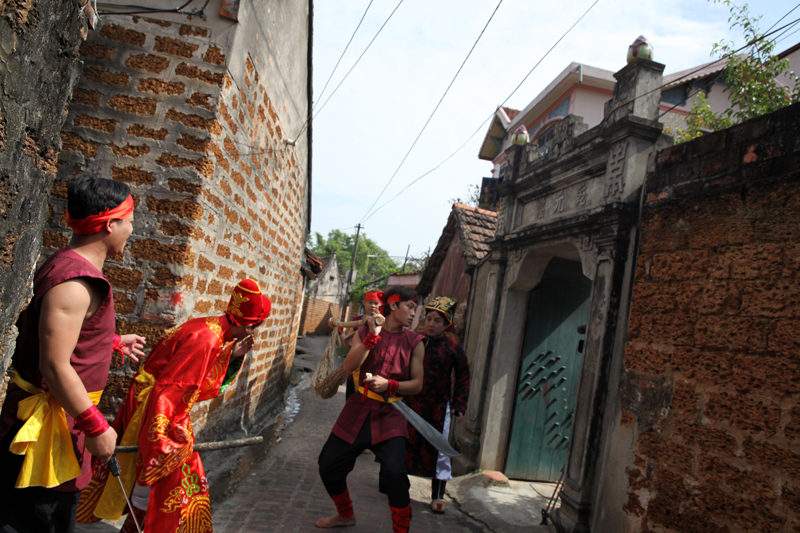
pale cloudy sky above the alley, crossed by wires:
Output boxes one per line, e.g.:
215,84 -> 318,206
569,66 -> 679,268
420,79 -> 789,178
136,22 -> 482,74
311,0 -> 800,262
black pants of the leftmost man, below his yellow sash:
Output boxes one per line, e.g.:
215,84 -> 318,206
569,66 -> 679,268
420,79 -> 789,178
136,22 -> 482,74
0,421 -> 81,533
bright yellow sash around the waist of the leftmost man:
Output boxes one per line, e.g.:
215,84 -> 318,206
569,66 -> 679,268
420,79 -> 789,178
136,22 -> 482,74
9,372 -> 103,489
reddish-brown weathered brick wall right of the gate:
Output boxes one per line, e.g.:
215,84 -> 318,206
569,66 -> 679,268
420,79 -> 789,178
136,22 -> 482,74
621,105 -> 800,533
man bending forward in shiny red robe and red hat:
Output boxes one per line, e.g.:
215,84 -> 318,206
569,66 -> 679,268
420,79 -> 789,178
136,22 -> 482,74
78,279 -> 272,533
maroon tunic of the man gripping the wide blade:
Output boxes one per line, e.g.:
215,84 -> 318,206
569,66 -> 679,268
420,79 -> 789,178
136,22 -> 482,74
332,326 -> 424,444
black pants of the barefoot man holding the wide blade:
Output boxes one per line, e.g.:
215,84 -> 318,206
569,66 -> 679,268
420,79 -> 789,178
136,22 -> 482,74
318,416 -> 411,509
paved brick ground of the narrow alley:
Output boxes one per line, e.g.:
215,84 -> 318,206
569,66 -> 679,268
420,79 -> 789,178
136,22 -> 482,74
212,338 -> 489,533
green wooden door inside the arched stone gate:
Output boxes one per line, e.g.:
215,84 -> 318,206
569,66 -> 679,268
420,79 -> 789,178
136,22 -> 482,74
505,278 -> 591,481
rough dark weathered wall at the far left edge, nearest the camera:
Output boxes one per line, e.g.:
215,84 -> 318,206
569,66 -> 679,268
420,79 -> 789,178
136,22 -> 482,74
0,0 -> 88,404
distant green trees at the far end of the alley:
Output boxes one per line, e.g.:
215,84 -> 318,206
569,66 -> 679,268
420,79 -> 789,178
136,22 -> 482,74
308,229 -> 400,302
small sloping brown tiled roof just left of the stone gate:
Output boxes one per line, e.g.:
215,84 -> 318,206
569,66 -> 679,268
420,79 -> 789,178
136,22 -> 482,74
417,204 -> 497,295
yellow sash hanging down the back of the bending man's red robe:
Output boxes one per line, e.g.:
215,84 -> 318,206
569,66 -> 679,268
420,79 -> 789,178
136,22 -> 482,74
94,368 -> 156,520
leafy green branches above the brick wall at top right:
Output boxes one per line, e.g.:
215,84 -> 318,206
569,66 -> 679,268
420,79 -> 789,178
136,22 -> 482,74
667,0 -> 800,143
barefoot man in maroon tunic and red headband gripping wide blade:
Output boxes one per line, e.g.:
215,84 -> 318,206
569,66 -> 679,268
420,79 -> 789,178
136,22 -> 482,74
316,287 -> 425,533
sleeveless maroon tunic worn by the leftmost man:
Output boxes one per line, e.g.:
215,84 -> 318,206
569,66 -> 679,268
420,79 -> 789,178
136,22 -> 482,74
0,248 -> 114,491
